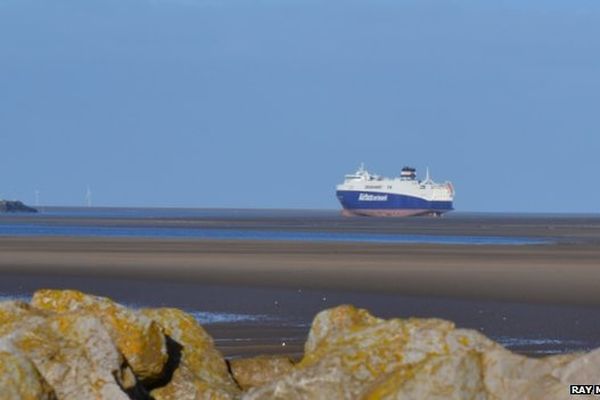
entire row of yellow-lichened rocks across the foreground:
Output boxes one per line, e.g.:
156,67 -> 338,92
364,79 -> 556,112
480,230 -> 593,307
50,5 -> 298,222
0,290 -> 600,400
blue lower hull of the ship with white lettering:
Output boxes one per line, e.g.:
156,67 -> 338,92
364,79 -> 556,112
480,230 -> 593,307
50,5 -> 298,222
336,190 -> 454,216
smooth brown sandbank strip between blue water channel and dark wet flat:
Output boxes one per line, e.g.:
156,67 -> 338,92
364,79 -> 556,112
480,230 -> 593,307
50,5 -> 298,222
0,238 -> 600,307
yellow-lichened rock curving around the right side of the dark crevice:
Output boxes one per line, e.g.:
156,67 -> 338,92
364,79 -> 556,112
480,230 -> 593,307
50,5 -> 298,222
141,308 -> 240,400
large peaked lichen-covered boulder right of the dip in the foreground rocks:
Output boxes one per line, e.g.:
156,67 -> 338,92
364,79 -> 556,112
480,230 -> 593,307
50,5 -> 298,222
244,306 -> 498,399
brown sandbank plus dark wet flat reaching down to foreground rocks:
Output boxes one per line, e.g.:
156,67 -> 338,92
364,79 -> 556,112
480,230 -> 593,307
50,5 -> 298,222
0,235 -> 600,357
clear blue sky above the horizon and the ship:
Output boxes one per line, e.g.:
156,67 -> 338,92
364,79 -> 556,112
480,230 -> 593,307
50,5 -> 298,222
0,0 -> 600,213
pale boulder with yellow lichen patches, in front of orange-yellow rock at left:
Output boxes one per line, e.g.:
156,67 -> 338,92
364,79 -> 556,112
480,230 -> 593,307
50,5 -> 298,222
11,313 -> 136,400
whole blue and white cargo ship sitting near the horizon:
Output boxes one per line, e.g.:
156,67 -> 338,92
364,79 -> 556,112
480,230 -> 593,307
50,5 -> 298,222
336,164 -> 454,217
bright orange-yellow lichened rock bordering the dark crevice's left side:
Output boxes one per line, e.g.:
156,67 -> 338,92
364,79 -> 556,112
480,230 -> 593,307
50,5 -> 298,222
31,290 -> 168,382
